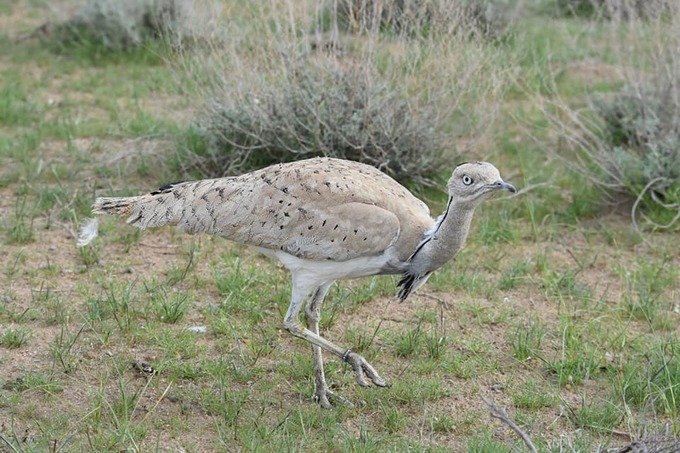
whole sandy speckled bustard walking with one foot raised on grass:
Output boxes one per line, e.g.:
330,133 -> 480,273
79,158 -> 515,407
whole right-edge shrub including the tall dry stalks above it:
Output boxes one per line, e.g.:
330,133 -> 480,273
537,5 -> 680,228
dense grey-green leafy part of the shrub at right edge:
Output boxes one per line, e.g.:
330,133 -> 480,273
589,78 -> 680,209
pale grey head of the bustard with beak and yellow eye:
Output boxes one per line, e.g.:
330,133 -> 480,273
447,162 -> 517,206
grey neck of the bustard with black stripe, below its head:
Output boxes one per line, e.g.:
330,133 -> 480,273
411,198 -> 475,274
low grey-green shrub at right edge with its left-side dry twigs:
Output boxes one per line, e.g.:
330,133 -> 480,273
540,74 -> 680,228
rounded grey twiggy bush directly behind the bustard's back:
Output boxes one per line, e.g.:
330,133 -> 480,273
193,61 -> 444,182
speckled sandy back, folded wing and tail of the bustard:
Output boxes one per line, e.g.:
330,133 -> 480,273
109,158 -> 433,261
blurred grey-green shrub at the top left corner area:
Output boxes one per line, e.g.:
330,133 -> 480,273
48,0 -> 215,52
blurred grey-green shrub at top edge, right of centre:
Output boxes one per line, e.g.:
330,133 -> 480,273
328,0 -> 513,38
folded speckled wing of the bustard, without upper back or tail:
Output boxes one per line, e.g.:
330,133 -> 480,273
163,178 -> 400,261
